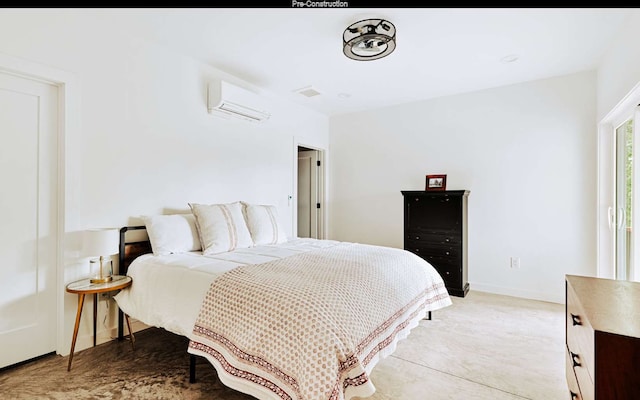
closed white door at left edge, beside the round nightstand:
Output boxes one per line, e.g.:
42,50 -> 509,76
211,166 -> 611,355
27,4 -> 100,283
0,72 -> 58,368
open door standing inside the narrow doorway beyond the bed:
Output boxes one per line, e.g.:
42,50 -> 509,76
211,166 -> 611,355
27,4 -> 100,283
298,150 -> 319,239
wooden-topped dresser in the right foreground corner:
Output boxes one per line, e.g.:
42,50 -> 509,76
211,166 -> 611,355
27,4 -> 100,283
565,275 -> 640,400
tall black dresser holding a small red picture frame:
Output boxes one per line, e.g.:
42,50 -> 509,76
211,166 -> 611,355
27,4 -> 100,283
402,190 -> 469,297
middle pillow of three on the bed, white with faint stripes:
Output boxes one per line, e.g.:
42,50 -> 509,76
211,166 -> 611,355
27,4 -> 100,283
189,201 -> 253,255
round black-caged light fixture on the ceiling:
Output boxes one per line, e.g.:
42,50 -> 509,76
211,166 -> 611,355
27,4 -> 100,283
342,19 -> 396,61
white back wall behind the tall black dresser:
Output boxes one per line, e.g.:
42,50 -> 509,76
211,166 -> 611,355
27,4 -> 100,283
329,72 -> 596,303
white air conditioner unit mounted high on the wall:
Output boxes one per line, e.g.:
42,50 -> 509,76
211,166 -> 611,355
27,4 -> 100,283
207,80 -> 271,122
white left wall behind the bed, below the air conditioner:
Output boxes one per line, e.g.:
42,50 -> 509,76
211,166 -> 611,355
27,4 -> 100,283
0,10 -> 328,354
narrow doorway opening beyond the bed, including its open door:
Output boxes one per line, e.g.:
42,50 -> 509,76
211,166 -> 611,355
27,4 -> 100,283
296,145 -> 325,239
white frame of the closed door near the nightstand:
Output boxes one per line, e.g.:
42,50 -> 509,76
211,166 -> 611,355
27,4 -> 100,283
0,53 -> 80,354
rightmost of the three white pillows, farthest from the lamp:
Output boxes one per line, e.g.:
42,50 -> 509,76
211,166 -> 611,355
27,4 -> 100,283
242,203 -> 287,244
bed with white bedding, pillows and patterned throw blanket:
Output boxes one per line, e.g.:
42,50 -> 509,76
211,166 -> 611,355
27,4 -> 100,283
115,202 -> 451,400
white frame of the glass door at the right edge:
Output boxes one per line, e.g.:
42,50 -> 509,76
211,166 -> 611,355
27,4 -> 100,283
596,83 -> 640,279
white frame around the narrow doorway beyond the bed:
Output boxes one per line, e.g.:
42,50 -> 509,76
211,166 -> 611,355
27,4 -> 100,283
290,137 -> 329,239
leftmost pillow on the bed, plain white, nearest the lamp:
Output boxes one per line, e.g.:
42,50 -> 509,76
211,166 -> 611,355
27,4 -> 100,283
141,214 -> 202,256
